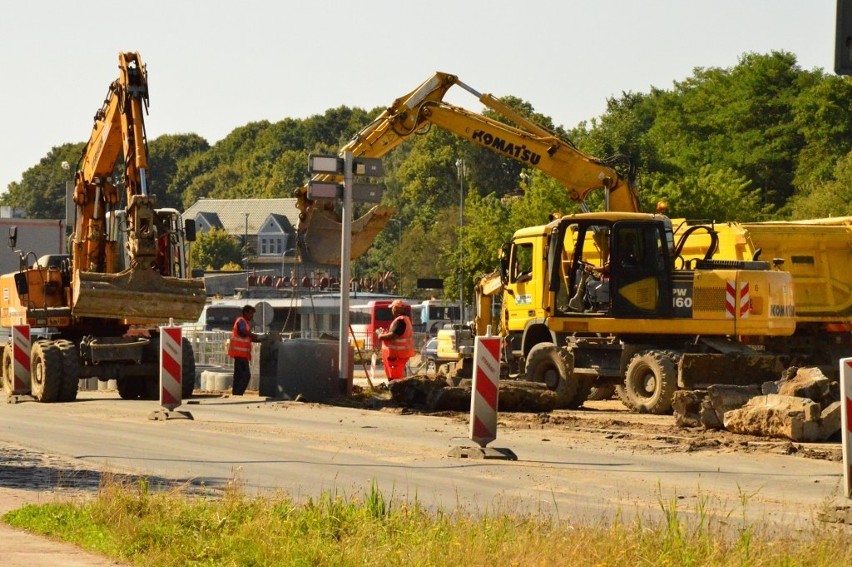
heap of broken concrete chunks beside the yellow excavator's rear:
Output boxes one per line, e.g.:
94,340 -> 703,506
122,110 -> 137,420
673,368 -> 841,442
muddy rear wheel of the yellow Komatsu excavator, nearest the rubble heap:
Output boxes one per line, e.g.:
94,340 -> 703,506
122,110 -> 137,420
624,350 -> 677,414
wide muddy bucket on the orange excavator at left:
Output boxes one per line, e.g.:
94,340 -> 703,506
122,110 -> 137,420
71,269 -> 207,323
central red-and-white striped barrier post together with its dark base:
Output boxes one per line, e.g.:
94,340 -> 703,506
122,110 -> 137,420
449,336 -> 518,461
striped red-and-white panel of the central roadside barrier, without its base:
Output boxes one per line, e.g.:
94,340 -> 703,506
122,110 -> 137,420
470,337 -> 500,447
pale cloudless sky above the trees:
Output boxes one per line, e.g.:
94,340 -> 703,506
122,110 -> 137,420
0,0 -> 836,192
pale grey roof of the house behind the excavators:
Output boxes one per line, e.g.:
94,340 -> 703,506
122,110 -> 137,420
183,197 -> 299,234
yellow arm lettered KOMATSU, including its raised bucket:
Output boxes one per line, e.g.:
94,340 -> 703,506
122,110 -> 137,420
296,72 -> 639,264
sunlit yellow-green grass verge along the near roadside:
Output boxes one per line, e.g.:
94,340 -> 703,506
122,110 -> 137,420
2,480 -> 852,567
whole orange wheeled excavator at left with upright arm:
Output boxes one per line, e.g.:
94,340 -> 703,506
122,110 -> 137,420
0,52 -> 206,402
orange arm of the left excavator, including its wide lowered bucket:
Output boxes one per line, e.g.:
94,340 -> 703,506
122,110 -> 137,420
71,52 -> 205,321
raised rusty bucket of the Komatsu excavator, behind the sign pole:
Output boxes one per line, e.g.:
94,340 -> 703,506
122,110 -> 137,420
303,205 -> 393,265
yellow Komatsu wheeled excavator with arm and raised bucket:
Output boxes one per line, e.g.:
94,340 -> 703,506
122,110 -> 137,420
296,73 -> 795,413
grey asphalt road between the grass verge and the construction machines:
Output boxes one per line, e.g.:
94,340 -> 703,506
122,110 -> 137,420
0,392 -> 848,527
